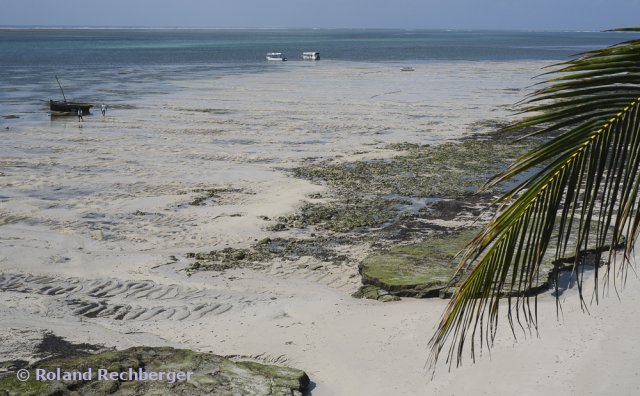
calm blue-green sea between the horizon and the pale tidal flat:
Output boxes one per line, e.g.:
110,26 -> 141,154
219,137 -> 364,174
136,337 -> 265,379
0,29 -> 637,116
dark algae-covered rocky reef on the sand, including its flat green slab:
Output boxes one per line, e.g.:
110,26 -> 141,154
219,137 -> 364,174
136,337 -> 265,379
189,128 -> 556,301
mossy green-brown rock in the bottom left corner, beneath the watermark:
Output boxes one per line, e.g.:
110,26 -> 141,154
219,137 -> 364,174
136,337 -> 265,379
0,347 -> 309,396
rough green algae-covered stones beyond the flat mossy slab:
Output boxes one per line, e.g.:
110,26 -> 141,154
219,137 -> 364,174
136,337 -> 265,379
276,135 -> 539,233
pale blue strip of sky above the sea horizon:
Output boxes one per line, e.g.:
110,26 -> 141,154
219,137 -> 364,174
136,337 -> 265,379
0,0 -> 640,30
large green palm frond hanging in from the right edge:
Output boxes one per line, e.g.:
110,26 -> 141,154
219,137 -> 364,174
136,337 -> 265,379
430,33 -> 640,365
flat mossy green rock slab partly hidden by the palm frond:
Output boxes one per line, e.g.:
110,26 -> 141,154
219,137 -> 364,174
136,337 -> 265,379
359,229 -> 477,297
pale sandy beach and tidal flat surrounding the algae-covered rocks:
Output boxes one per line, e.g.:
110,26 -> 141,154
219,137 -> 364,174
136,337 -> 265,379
0,61 -> 640,395
